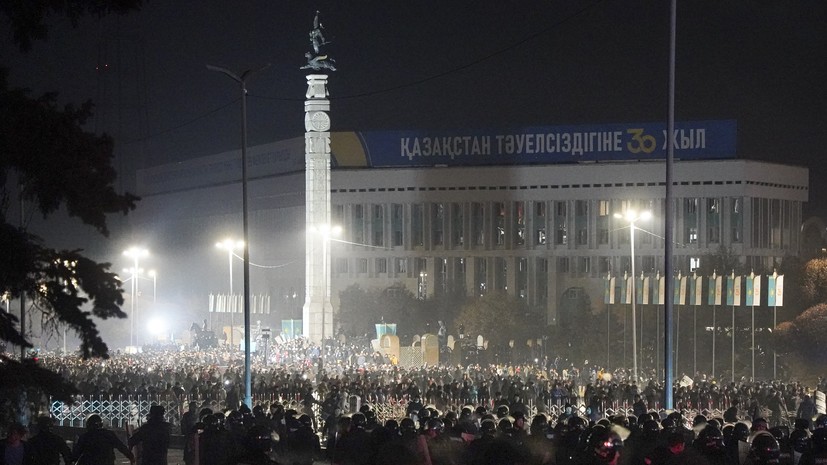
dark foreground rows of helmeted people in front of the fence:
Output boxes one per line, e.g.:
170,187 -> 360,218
0,392 -> 827,465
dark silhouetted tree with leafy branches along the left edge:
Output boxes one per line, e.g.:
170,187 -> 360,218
0,0 -> 141,406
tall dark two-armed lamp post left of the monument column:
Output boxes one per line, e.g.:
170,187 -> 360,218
207,64 -> 270,408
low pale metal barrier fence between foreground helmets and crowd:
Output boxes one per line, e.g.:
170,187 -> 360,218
49,396 -> 744,428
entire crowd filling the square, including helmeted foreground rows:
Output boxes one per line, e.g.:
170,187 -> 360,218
0,339 -> 827,465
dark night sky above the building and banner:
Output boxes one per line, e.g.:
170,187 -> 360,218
0,0 -> 827,214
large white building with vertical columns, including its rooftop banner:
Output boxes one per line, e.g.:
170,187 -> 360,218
130,122 -> 808,330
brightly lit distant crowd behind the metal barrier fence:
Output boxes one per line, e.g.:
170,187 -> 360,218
32,338 -> 827,423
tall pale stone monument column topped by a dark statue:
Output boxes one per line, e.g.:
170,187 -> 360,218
301,11 -> 336,343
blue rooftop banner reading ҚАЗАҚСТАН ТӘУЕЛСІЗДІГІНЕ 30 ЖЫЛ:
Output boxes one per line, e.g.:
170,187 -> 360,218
331,120 -> 737,167
